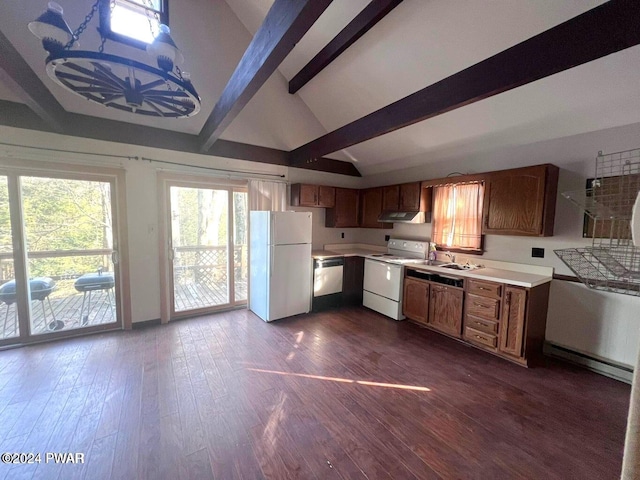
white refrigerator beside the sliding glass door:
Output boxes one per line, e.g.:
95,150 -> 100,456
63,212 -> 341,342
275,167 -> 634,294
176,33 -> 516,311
249,211 -> 313,322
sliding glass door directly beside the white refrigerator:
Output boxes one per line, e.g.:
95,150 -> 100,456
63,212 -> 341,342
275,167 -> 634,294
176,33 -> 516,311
168,182 -> 247,318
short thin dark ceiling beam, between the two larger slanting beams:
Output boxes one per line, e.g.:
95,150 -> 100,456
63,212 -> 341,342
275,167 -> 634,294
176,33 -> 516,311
289,0 -> 402,93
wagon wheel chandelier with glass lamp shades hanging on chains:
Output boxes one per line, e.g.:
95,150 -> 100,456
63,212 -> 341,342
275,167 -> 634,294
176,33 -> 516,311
29,0 -> 200,118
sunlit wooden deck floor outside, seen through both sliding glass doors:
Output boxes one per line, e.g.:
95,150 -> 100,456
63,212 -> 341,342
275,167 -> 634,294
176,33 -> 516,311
0,282 -> 247,338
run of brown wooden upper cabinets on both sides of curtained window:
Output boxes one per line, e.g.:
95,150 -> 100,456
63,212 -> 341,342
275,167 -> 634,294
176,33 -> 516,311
291,164 -> 559,237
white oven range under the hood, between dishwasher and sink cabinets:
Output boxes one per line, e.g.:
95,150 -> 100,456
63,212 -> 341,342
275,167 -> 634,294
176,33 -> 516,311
362,238 -> 429,320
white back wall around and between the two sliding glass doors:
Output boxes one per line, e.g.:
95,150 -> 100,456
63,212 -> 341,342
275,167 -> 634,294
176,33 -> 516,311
0,127 -> 360,322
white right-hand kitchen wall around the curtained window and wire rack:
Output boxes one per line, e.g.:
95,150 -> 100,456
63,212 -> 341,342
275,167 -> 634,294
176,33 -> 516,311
357,124 -> 640,365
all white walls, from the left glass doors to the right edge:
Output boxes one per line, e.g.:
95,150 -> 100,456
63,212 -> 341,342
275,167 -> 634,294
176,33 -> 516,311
0,124 -> 640,365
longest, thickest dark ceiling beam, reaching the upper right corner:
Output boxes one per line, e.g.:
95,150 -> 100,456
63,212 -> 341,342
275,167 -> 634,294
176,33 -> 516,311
291,0 -> 640,166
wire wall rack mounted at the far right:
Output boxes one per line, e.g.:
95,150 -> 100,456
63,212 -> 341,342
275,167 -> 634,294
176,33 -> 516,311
554,149 -> 640,296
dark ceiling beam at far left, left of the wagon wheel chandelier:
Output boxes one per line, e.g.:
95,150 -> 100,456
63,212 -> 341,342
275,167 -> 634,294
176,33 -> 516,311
0,32 -> 66,133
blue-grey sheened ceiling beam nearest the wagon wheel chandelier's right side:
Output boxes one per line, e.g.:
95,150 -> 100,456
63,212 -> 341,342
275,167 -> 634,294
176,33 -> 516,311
199,0 -> 331,153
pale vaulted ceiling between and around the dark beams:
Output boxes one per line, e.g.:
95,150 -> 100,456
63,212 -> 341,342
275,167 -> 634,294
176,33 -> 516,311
0,0 -> 640,175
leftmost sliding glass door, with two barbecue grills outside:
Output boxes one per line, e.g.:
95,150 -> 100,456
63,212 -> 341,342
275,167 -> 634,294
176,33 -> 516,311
0,167 -> 122,345
